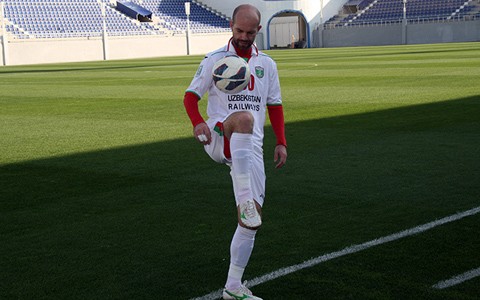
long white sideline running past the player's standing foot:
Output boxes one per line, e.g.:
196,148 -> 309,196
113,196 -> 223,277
192,206 -> 480,300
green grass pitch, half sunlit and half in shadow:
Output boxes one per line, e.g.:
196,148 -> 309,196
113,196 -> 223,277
0,43 -> 480,299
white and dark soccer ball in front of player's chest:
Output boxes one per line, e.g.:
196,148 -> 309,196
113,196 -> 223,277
212,55 -> 250,94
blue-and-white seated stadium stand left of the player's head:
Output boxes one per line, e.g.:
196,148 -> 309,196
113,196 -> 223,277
0,0 -> 229,39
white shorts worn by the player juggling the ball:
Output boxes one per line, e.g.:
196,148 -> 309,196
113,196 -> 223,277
205,122 -> 266,206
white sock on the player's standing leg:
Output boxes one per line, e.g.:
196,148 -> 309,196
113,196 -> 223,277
225,225 -> 257,290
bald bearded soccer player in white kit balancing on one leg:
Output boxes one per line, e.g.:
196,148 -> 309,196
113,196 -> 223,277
184,4 -> 287,300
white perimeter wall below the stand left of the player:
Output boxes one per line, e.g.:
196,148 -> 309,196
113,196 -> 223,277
0,33 -> 231,65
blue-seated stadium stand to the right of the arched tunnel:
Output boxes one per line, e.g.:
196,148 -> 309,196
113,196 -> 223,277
325,0 -> 478,28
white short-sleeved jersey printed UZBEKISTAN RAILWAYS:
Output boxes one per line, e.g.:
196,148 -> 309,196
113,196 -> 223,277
187,40 -> 282,148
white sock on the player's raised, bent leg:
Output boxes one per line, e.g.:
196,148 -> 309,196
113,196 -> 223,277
230,132 -> 253,205
